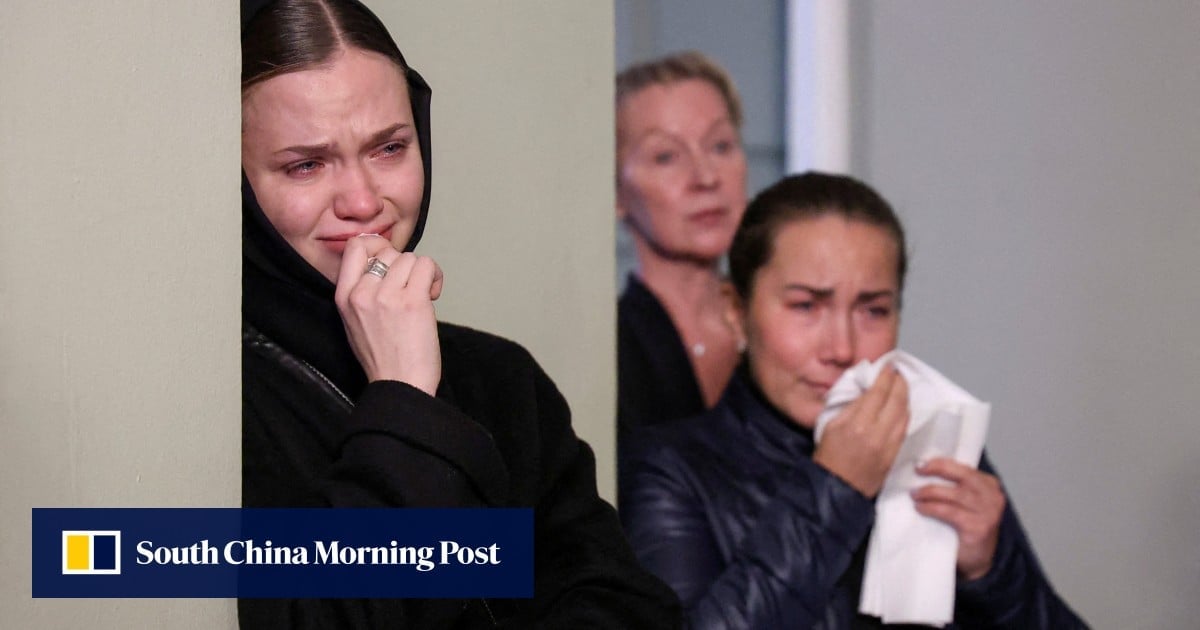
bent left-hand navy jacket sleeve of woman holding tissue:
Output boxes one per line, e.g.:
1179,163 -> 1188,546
622,436 -> 875,629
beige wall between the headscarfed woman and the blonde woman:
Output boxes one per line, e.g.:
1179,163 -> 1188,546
379,0 -> 616,499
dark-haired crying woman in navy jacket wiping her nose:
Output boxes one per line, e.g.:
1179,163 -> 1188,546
620,173 -> 1084,629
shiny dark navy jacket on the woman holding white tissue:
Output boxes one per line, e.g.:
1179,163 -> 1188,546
619,371 -> 1085,630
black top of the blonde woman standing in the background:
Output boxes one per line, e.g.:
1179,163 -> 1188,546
617,274 -> 704,436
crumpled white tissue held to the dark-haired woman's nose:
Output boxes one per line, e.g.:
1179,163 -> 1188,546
815,350 -> 991,625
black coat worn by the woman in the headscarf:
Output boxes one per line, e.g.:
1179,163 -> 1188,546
239,324 -> 679,629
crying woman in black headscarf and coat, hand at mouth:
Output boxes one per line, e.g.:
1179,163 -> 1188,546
239,0 -> 678,628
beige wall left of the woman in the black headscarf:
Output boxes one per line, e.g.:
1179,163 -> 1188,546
0,0 -> 240,628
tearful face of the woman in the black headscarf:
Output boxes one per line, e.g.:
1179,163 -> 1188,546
241,49 -> 425,282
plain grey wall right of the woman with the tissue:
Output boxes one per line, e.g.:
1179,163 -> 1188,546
851,0 -> 1200,630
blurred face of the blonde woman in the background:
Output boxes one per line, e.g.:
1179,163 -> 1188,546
617,79 -> 746,262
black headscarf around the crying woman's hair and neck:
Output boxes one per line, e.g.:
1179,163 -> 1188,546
241,0 -> 432,398
